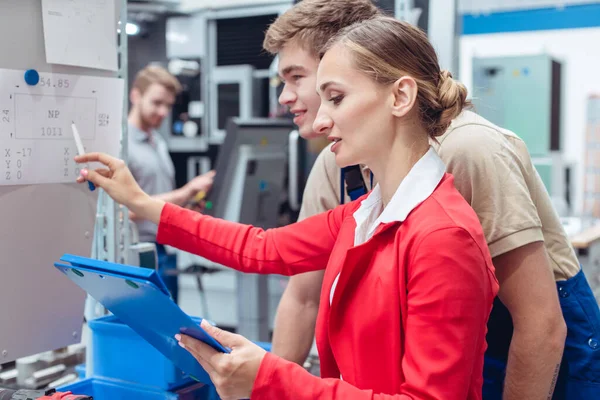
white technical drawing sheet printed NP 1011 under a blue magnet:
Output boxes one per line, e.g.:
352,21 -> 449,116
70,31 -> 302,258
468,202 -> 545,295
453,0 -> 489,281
0,69 -> 124,185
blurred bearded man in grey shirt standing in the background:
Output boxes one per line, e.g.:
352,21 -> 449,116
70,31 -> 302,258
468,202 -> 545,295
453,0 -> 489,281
128,66 -> 214,302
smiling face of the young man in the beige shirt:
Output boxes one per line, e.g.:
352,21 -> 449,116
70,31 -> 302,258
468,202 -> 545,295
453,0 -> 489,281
279,43 -> 321,139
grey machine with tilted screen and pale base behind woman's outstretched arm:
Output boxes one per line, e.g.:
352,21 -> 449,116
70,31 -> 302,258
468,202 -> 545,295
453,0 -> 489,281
173,118 -> 301,341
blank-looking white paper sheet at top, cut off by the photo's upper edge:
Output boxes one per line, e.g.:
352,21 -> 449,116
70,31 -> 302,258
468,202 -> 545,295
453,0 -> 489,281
42,0 -> 118,71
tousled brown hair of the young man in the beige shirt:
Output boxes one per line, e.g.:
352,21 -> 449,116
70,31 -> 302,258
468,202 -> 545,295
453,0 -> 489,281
263,0 -> 380,57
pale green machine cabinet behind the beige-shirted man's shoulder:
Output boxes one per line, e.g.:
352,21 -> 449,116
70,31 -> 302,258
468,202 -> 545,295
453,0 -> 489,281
473,54 -> 571,211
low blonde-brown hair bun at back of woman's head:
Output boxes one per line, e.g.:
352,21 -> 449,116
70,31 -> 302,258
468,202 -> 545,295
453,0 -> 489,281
432,70 -> 470,136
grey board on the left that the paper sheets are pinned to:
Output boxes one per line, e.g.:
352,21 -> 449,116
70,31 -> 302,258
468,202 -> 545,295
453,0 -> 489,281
0,0 -> 120,364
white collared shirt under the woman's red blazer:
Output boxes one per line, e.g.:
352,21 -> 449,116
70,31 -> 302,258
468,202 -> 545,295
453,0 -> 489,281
329,147 -> 446,305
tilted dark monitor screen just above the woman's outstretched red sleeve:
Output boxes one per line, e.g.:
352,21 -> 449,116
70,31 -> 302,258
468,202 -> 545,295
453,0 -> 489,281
205,118 -> 294,228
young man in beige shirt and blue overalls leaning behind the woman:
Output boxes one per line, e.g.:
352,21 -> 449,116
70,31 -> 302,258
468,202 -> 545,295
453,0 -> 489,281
264,0 -> 600,400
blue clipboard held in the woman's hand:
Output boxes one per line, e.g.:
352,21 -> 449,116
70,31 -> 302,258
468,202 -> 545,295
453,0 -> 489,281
54,254 -> 229,384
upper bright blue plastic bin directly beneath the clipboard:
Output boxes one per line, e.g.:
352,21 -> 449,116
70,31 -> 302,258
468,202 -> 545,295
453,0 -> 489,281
88,315 -> 199,390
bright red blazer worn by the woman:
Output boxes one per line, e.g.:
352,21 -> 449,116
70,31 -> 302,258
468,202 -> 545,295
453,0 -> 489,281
158,174 -> 498,400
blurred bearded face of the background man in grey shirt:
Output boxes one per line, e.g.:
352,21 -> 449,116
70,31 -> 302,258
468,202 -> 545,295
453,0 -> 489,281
131,83 -> 175,129
